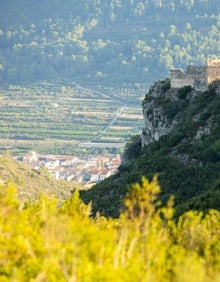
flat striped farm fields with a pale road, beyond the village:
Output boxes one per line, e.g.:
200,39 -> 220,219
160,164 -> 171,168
0,82 -> 146,156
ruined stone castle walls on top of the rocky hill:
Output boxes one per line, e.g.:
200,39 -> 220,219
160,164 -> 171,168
170,58 -> 220,91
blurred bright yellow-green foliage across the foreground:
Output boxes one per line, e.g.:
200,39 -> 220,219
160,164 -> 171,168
0,178 -> 220,282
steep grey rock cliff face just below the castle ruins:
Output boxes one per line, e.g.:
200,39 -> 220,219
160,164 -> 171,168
141,78 -> 199,146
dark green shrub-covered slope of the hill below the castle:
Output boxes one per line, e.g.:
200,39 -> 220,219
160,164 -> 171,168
81,81 -> 220,217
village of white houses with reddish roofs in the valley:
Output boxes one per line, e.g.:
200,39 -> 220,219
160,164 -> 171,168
19,151 -> 121,184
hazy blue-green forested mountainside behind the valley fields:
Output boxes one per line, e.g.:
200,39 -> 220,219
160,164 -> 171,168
0,0 -> 220,83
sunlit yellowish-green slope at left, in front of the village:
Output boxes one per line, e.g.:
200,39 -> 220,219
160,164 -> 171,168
0,154 -> 76,204
